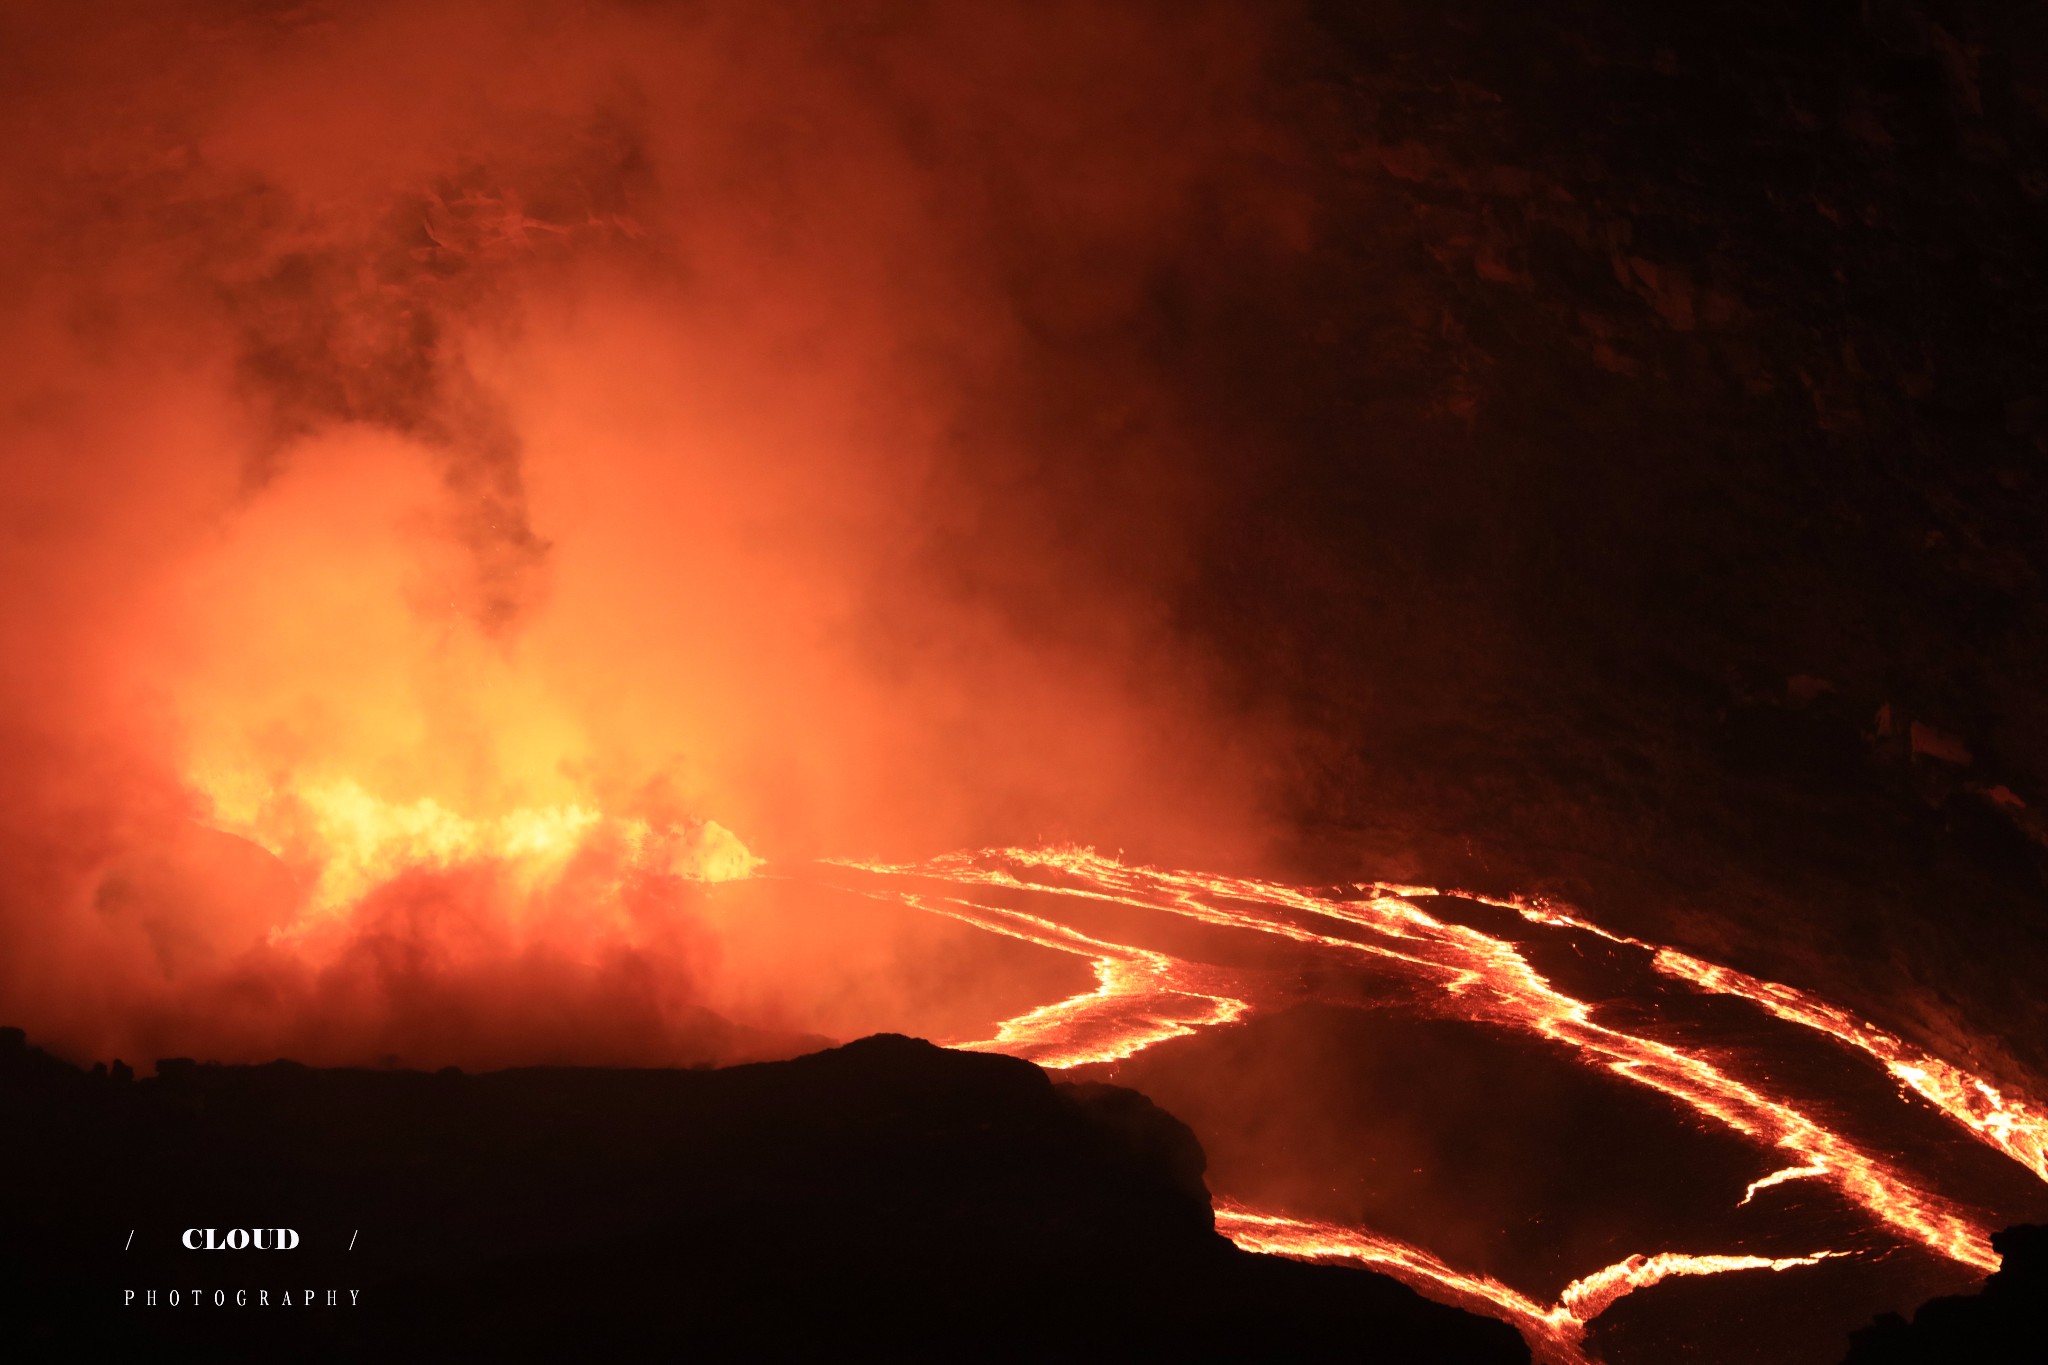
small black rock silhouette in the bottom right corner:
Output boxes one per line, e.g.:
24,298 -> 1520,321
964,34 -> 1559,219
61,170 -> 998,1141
1843,1226 -> 2048,1365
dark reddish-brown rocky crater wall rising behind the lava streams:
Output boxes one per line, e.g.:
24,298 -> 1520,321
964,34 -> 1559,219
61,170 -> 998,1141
1159,0 -> 2048,1089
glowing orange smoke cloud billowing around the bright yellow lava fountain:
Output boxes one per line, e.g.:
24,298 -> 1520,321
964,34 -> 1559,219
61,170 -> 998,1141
0,0 -> 1298,1064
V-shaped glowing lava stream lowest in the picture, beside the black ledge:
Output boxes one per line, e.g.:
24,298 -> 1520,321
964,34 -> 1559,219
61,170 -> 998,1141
1217,1199 -> 1847,1365
